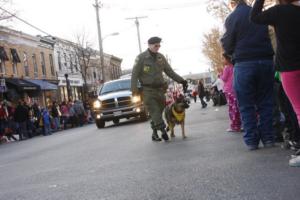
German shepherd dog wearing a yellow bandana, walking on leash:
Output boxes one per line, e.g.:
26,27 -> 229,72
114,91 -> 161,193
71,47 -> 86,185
164,95 -> 190,139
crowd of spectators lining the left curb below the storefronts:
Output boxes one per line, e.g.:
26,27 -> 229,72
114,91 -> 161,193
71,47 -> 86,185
0,99 -> 93,142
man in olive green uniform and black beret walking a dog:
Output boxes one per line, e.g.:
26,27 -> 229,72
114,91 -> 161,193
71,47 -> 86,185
131,37 -> 187,141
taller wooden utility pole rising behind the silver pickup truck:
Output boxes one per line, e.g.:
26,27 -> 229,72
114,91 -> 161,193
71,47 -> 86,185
93,0 -> 105,82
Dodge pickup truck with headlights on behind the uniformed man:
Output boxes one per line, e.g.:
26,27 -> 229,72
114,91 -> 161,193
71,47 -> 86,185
93,78 -> 149,128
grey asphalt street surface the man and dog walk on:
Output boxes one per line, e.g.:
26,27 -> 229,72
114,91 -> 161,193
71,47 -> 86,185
0,103 -> 300,200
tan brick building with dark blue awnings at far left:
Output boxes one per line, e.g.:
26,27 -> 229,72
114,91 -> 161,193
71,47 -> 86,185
0,26 -> 57,105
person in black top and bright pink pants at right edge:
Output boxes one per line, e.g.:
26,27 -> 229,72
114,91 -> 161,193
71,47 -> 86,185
251,0 -> 300,167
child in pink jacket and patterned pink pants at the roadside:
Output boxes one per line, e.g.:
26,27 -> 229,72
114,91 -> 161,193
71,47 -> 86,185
220,55 -> 241,132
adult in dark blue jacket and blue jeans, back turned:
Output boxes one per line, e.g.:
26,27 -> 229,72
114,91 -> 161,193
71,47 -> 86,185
221,0 -> 274,150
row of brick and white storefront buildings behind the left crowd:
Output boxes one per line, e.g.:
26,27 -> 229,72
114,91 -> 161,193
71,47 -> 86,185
0,26 -> 122,106
